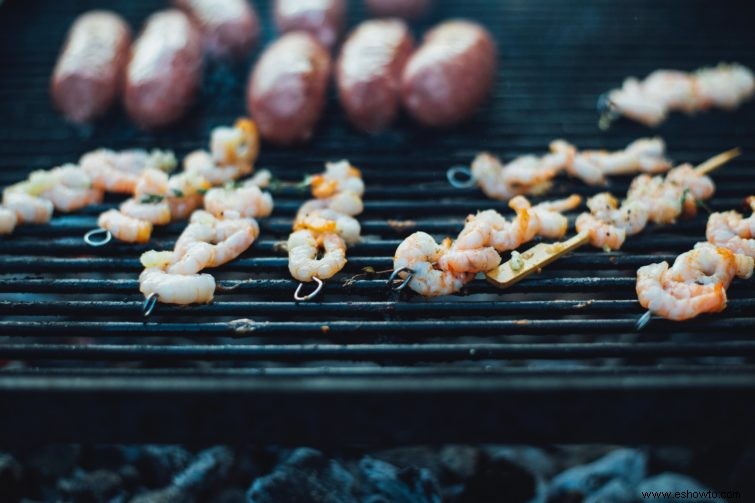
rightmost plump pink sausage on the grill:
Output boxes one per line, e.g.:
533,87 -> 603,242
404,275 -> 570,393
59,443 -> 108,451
401,21 -> 496,127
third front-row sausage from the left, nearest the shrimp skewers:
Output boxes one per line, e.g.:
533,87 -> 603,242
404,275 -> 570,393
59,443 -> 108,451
247,32 -> 330,145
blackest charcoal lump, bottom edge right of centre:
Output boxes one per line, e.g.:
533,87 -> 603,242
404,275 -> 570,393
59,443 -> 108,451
456,458 -> 538,503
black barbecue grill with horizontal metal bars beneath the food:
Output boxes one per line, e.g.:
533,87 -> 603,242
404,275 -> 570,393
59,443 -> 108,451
0,0 -> 755,445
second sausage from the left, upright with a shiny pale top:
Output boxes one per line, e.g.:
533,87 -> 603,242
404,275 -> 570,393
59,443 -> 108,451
124,9 -> 202,129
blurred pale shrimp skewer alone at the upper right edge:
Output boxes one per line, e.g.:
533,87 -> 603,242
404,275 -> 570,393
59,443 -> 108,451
600,63 -> 755,129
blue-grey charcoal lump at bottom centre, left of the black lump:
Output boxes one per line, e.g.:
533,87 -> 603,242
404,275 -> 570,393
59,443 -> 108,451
359,457 -> 441,503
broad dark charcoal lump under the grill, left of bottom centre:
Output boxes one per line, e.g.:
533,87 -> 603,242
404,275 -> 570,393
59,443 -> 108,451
246,448 -> 358,503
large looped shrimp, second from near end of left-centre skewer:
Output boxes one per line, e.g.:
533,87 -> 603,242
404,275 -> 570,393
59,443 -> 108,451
167,210 -> 259,274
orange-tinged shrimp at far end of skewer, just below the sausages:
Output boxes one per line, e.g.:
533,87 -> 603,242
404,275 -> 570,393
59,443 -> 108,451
210,119 -> 260,167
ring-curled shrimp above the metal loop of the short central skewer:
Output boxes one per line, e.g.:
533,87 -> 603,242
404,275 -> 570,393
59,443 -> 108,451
288,229 -> 346,282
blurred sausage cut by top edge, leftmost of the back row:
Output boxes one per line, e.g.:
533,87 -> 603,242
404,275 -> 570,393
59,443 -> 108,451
173,0 -> 260,59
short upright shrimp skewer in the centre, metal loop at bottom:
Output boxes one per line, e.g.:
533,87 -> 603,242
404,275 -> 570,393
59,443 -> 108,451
287,160 -> 364,301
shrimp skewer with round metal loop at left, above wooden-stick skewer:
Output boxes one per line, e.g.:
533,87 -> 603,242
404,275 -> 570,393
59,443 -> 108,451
447,138 -> 671,201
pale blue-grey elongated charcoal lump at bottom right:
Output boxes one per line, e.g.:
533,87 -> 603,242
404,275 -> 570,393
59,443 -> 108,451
549,449 -> 647,501
